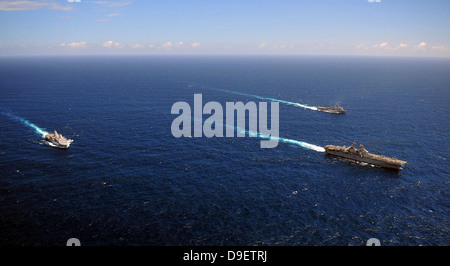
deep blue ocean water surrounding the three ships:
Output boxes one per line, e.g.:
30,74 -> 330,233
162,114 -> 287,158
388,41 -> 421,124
0,56 -> 450,246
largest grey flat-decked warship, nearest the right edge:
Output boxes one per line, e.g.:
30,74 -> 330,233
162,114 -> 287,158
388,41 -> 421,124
325,142 -> 406,170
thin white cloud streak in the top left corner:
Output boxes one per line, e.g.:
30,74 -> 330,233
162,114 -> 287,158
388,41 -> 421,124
0,0 -> 73,11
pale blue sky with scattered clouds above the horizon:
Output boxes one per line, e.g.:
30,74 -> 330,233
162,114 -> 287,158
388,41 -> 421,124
0,0 -> 450,58
